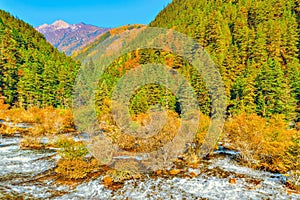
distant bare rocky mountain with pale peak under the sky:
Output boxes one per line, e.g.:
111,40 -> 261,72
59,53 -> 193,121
36,20 -> 110,55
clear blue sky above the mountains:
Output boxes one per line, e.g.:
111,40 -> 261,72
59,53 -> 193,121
0,0 -> 172,27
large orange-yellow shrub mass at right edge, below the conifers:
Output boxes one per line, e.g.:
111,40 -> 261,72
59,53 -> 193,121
224,113 -> 299,173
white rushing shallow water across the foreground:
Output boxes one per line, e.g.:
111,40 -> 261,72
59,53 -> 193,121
0,137 -> 300,199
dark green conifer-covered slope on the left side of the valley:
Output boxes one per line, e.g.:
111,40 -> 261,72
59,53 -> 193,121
0,10 -> 79,107
